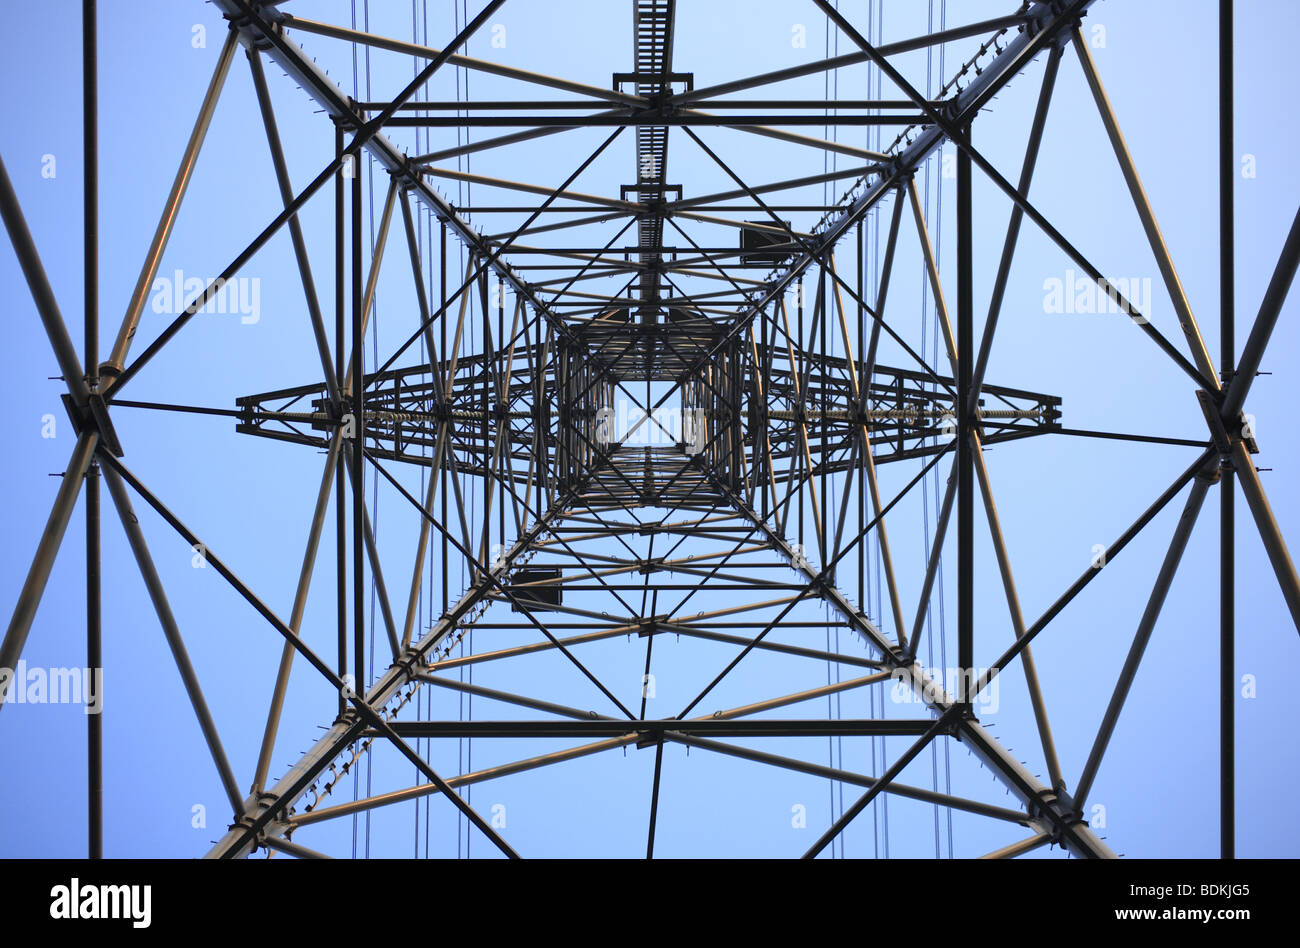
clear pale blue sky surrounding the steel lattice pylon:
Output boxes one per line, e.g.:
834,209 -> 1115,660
0,0 -> 1300,856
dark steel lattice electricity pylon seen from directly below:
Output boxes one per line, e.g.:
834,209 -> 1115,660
0,0 -> 1300,857
